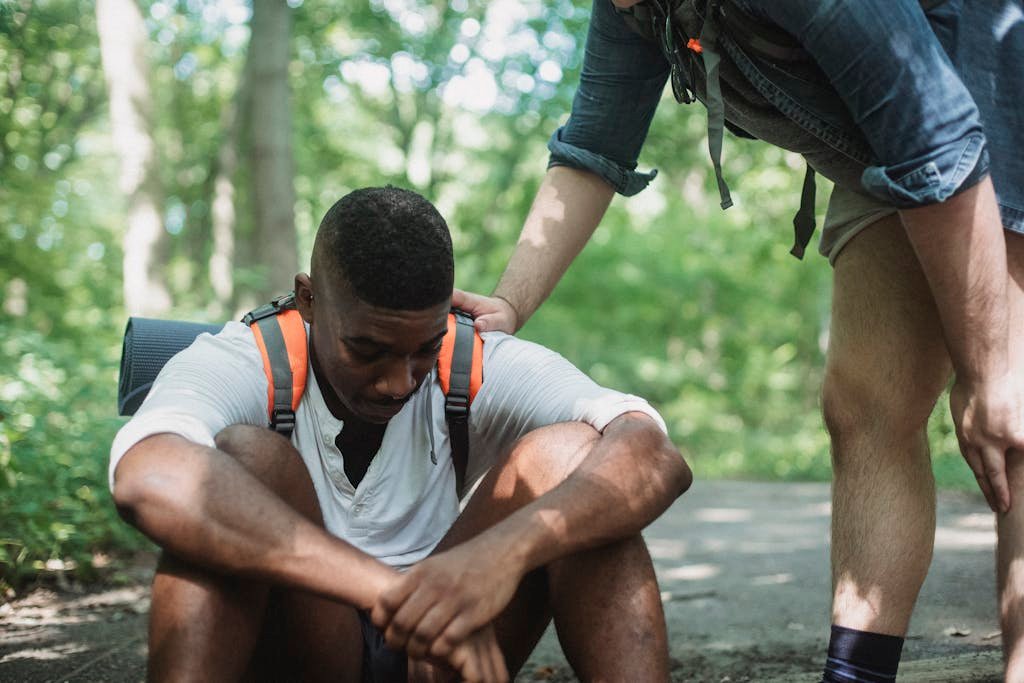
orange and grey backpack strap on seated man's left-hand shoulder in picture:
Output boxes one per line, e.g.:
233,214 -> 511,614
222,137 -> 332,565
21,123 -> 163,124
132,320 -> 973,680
242,294 -> 309,436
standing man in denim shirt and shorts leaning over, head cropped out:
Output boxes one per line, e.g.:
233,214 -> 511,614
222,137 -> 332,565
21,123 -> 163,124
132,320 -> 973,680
456,0 -> 1024,681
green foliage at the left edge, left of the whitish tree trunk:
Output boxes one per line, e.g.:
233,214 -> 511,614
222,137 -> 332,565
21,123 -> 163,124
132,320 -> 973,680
0,1 -> 150,589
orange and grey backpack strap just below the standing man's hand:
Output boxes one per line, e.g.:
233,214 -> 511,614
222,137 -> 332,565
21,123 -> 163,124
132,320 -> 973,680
437,309 -> 483,498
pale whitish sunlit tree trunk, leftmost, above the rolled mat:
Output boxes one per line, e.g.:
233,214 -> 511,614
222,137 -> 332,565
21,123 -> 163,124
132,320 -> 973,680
96,0 -> 171,315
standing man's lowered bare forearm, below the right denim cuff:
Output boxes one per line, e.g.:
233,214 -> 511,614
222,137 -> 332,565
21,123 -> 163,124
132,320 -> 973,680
900,178 -> 1009,383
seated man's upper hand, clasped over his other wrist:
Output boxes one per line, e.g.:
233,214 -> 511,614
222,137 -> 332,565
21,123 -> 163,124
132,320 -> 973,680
372,540 -> 523,661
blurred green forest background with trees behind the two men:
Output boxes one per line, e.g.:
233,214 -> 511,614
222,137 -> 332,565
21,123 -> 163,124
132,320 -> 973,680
0,0 -> 974,602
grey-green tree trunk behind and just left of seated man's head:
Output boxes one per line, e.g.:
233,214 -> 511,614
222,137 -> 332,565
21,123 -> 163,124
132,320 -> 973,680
241,0 -> 299,302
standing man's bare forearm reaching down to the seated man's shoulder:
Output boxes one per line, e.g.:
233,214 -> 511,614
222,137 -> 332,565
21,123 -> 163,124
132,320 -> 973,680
495,166 -> 614,328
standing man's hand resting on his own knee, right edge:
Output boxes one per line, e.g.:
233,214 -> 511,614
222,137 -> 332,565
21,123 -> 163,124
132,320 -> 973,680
949,373 -> 1024,513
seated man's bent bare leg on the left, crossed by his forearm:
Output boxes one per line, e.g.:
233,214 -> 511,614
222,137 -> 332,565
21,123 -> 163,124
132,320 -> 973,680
148,427 -> 362,681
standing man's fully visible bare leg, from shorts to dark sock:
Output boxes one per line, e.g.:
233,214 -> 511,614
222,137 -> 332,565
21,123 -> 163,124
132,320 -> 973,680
822,215 -> 951,636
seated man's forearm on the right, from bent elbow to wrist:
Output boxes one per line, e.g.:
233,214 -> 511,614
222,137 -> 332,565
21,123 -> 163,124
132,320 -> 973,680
481,415 -> 692,572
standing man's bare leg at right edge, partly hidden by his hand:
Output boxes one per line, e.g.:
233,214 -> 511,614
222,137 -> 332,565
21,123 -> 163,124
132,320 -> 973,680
996,232 -> 1024,683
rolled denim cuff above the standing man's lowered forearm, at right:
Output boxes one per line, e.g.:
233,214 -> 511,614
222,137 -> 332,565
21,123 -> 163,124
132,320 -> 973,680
860,133 -> 988,209
